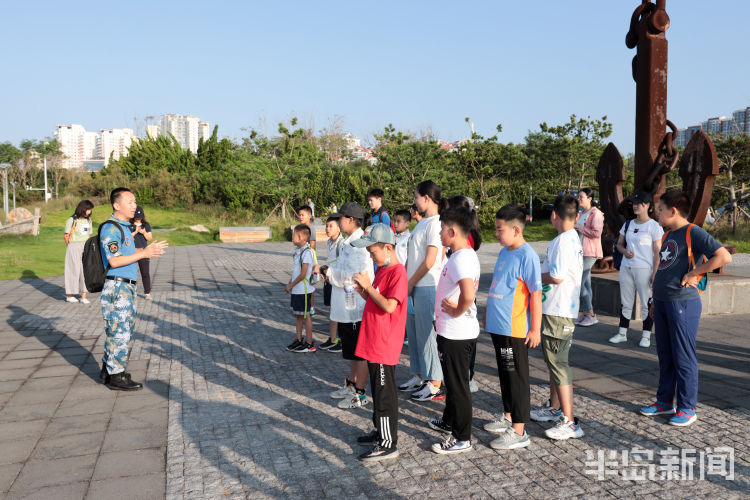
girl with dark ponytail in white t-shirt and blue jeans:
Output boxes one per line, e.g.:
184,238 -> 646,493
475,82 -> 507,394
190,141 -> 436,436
399,181 -> 446,401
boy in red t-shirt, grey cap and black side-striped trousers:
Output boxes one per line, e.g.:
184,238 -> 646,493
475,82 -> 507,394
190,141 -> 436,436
352,224 -> 409,462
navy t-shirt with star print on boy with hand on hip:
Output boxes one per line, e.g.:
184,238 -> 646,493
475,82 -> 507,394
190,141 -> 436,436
653,225 -> 721,302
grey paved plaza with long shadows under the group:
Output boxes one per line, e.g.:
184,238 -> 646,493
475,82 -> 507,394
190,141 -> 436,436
0,243 -> 750,499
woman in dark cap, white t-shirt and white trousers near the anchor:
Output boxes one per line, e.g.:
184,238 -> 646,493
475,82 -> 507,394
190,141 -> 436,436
609,191 -> 664,347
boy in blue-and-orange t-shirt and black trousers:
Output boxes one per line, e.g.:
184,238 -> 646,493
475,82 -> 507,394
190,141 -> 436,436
484,204 -> 542,450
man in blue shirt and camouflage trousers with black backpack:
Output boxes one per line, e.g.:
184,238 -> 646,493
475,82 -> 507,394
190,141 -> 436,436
99,188 -> 168,391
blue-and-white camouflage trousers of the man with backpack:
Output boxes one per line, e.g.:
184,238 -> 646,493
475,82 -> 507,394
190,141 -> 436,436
101,280 -> 135,375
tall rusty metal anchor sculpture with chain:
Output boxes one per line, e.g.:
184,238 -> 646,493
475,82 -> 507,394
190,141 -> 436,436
596,0 -> 719,272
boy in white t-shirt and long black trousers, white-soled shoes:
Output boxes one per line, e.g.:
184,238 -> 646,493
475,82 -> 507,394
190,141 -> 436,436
429,207 -> 480,454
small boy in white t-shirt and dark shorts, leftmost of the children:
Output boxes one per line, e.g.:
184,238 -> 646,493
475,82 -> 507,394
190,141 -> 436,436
284,224 -> 315,352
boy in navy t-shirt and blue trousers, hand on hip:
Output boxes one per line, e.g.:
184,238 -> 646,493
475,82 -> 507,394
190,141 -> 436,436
641,191 -> 732,426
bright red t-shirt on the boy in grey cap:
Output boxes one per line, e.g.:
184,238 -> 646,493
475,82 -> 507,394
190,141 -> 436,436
354,264 -> 409,365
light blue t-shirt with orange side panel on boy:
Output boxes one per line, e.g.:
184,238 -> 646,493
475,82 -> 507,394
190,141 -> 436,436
485,243 -> 542,338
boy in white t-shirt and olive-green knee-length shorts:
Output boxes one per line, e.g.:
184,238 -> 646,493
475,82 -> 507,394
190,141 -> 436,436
531,195 -> 583,439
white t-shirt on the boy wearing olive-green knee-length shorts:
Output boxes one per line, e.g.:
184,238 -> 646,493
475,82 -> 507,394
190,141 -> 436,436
541,229 -> 583,318
